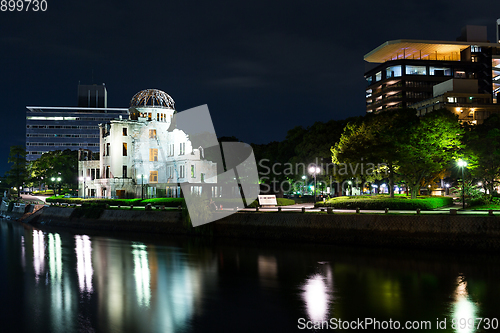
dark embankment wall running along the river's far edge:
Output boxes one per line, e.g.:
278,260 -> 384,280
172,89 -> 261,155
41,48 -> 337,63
24,207 -> 500,252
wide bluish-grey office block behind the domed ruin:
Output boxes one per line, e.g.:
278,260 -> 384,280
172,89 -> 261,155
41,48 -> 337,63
26,85 -> 128,161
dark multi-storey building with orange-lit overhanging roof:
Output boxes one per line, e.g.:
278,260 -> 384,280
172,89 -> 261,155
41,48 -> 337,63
364,21 -> 500,112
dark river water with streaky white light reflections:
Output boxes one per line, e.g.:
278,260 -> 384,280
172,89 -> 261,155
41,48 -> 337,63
0,221 -> 500,332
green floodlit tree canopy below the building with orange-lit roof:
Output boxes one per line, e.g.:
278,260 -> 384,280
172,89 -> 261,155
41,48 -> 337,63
331,109 -> 463,198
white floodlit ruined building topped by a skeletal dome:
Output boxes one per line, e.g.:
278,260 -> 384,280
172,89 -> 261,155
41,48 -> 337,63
78,89 -> 217,198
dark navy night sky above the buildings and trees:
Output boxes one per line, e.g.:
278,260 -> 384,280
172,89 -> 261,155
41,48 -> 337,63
0,0 -> 500,175
